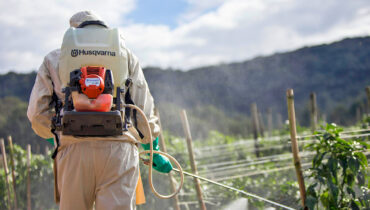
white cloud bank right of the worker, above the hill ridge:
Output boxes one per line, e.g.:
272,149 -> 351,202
122,0 -> 370,69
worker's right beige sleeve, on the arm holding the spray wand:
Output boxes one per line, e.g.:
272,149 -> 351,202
128,52 -> 160,144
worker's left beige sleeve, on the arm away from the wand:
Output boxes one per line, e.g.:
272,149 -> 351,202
27,58 -> 54,139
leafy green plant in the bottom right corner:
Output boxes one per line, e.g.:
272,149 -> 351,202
306,124 -> 370,209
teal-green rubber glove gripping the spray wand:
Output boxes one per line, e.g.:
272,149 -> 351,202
141,137 -> 173,173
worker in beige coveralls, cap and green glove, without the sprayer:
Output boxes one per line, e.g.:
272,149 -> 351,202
27,11 -> 172,210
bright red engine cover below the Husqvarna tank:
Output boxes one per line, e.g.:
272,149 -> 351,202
80,66 -> 105,99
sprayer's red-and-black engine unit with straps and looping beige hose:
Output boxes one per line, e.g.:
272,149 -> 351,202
53,66 -> 184,199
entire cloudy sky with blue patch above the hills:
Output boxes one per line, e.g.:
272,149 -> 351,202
0,0 -> 370,74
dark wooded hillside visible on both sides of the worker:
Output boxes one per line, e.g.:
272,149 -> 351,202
0,37 -> 370,146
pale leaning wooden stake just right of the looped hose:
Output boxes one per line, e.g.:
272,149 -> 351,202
180,110 -> 206,210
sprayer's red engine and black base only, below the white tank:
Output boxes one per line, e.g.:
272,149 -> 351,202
60,66 -> 125,136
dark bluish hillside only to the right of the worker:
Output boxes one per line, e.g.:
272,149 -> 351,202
145,37 -> 370,123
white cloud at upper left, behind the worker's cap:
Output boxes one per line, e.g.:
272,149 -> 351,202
0,0 -> 135,73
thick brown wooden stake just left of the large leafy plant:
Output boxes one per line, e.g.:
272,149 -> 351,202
287,89 -> 306,208
